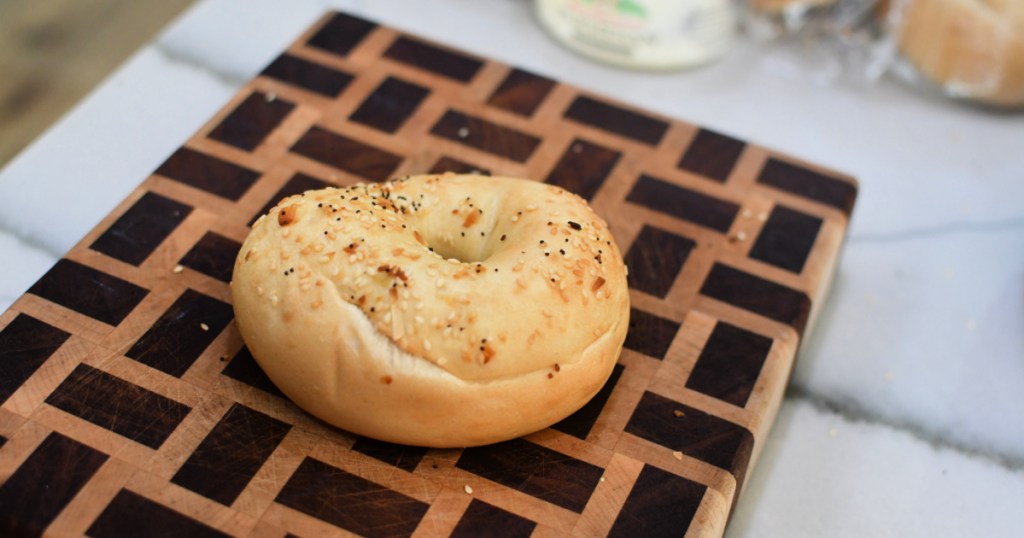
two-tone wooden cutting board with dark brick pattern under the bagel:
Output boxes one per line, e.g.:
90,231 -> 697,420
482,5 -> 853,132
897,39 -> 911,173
0,13 -> 857,536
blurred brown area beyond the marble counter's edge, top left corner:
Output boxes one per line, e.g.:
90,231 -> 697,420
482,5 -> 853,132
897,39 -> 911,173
0,0 -> 193,168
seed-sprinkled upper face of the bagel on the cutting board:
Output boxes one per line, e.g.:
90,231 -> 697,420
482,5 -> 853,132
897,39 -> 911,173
244,175 -> 625,384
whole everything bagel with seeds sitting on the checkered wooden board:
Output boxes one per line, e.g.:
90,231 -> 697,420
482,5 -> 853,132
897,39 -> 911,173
231,173 -> 630,448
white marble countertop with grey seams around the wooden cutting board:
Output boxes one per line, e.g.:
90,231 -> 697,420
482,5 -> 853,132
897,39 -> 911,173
0,0 -> 1024,537
